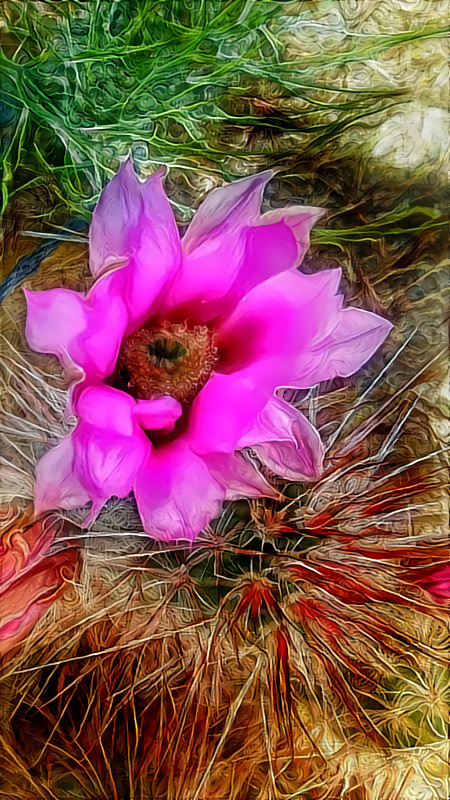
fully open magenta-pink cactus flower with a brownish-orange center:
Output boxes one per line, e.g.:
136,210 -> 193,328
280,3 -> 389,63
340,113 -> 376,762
26,162 -> 391,540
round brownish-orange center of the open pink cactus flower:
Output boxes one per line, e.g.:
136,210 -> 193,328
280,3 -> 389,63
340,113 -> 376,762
118,322 -> 217,403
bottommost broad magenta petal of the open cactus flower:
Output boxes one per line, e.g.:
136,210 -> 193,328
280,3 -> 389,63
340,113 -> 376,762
134,439 -> 225,541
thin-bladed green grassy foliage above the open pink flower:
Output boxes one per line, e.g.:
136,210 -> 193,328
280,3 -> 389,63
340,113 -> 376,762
0,0 -> 440,218
